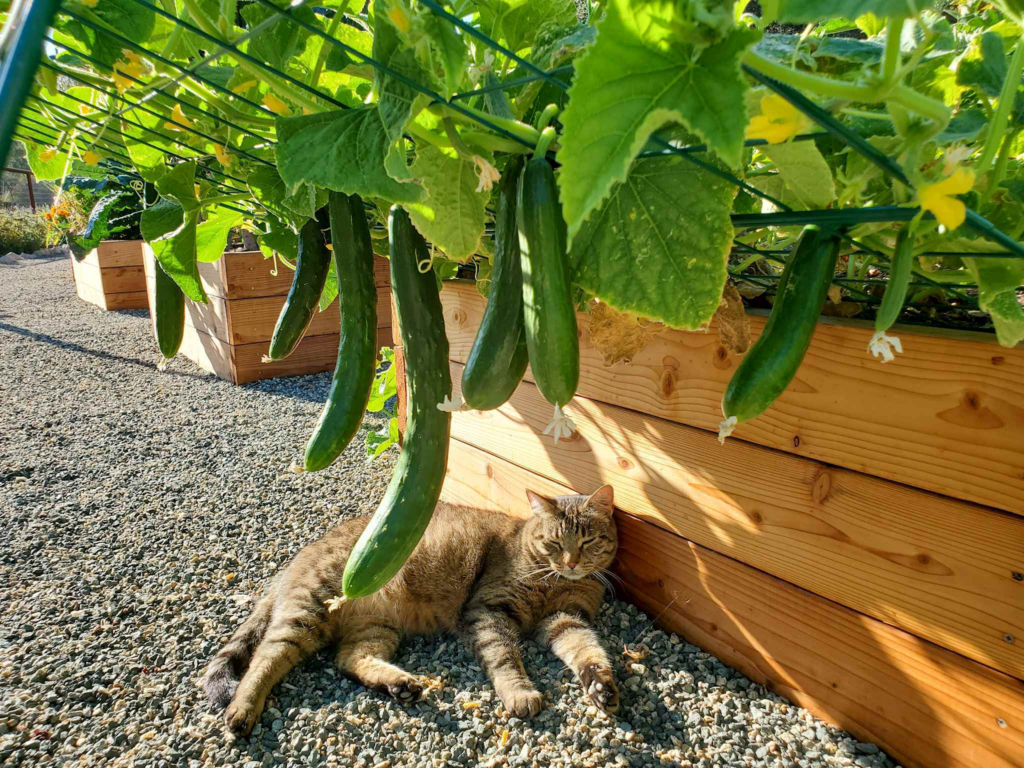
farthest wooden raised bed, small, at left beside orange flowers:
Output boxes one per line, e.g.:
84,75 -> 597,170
71,240 -> 150,310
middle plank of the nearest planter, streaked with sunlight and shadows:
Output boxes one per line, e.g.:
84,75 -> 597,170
452,364 -> 1024,677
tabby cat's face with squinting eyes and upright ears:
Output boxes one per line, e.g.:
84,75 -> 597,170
526,485 -> 618,581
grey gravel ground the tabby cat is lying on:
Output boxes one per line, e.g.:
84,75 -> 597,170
0,260 -> 894,768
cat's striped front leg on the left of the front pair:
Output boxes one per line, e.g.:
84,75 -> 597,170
463,606 -> 544,718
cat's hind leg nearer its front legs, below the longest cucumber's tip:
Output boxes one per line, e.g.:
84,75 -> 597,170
337,616 -> 423,703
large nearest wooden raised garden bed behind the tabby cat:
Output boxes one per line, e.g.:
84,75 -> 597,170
398,283 -> 1024,768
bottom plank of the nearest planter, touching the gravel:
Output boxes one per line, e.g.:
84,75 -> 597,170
442,440 -> 1024,768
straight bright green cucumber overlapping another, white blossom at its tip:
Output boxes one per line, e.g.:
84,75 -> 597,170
518,157 -> 580,406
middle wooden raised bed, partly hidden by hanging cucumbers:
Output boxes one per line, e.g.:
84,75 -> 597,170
144,246 -> 391,384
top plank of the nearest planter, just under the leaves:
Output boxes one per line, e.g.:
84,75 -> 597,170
441,283 -> 1024,514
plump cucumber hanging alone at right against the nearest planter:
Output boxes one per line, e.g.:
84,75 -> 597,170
718,224 -> 840,442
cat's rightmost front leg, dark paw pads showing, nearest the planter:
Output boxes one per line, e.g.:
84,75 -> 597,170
537,610 -> 618,712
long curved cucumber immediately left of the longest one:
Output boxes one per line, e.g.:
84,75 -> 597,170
305,191 -> 377,472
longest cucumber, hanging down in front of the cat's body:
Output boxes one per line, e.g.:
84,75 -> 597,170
342,206 -> 452,599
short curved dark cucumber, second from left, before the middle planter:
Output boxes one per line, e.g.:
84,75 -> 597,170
266,219 -> 331,360
